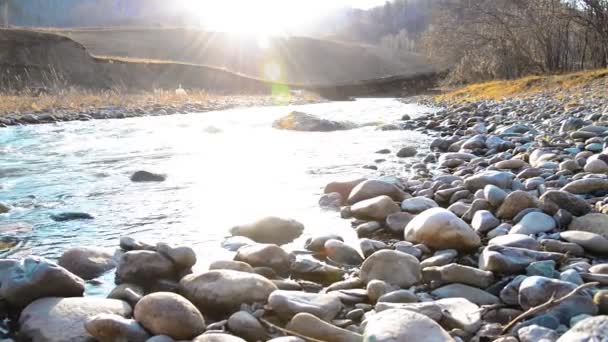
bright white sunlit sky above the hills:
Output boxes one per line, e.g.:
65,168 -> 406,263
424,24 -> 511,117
182,0 -> 385,35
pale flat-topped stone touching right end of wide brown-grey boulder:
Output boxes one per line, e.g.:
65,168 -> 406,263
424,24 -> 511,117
268,290 -> 342,321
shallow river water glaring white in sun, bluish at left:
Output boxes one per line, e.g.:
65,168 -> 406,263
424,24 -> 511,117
0,99 -> 432,292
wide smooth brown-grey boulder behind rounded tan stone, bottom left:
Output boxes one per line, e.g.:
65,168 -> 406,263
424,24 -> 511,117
179,270 -> 277,315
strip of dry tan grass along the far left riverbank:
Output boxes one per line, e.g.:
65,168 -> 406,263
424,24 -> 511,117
0,90 -> 302,114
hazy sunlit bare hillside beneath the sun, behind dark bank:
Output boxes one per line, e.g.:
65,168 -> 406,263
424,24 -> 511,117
54,28 -> 434,85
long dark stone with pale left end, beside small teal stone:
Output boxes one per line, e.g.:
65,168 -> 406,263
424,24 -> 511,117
479,245 -> 564,274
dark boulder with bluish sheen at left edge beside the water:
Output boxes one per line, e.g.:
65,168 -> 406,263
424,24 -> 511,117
0,256 -> 84,308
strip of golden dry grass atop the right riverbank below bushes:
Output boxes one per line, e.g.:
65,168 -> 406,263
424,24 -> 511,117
437,69 -> 608,102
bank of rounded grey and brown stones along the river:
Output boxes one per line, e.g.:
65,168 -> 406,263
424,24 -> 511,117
0,89 -> 608,342
